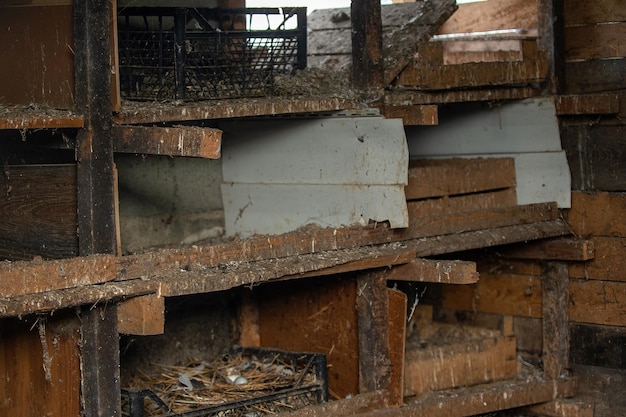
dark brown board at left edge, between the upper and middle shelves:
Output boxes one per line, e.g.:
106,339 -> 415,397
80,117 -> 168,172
0,164 -> 78,260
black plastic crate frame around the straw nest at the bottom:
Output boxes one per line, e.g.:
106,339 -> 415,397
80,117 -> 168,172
122,348 -> 328,417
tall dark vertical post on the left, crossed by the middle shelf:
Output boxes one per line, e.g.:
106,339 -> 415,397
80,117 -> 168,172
74,0 -> 121,417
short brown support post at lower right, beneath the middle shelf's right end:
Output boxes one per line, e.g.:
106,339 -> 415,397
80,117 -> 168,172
541,262 -> 569,379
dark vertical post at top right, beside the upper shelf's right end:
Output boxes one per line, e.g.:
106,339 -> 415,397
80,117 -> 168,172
537,0 -> 565,94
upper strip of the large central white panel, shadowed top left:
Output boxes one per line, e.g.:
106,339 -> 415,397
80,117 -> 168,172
220,117 -> 408,184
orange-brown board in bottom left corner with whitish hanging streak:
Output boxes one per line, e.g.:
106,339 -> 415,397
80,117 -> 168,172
0,314 -> 81,417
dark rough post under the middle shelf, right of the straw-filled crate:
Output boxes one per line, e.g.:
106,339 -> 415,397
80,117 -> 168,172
356,272 -> 391,400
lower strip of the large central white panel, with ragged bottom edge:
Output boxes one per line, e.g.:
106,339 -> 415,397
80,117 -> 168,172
222,184 -> 408,236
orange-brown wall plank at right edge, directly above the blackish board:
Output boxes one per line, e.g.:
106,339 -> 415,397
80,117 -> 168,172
569,280 -> 626,326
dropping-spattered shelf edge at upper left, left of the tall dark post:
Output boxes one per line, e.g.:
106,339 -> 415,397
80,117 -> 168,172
0,106 -> 85,130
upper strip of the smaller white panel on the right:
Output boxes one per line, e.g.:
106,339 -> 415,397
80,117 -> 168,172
406,98 -> 561,156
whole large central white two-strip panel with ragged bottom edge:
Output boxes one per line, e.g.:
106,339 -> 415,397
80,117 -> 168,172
220,116 -> 409,236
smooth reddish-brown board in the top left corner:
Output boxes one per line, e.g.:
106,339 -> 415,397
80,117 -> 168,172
0,2 -> 75,109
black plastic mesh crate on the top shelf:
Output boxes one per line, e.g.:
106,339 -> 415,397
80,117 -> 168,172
118,7 -> 307,100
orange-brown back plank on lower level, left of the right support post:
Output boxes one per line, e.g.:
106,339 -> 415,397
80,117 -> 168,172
441,273 -> 543,318
